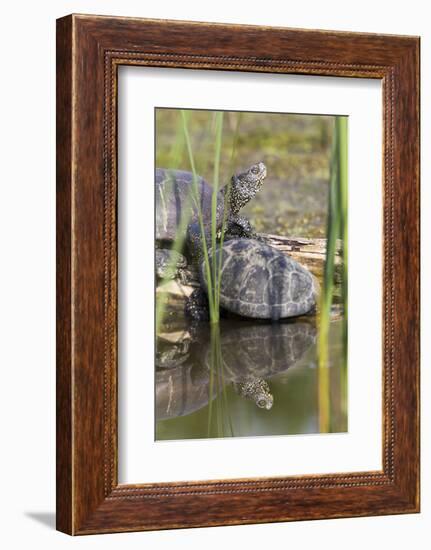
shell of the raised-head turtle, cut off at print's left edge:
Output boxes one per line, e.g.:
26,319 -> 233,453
155,168 -> 224,241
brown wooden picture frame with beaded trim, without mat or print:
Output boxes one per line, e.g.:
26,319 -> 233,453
57,15 -> 419,534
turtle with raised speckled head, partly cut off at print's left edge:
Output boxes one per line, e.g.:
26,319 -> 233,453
155,162 -> 267,280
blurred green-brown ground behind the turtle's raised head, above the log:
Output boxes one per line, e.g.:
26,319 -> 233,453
156,108 -> 335,238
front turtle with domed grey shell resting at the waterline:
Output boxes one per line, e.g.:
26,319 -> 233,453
185,238 -> 318,321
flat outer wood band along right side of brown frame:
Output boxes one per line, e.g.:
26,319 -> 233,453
393,38 -> 420,512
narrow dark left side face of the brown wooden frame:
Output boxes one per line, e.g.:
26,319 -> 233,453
56,16 -> 74,534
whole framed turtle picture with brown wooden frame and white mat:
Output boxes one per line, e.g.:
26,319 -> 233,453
57,15 -> 419,534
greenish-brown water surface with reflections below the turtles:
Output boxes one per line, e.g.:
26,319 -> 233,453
155,319 -> 347,440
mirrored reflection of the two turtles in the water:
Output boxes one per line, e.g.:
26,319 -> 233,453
156,321 -> 316,420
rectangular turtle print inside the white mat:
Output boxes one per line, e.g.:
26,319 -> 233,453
154,107 -> 348,441
